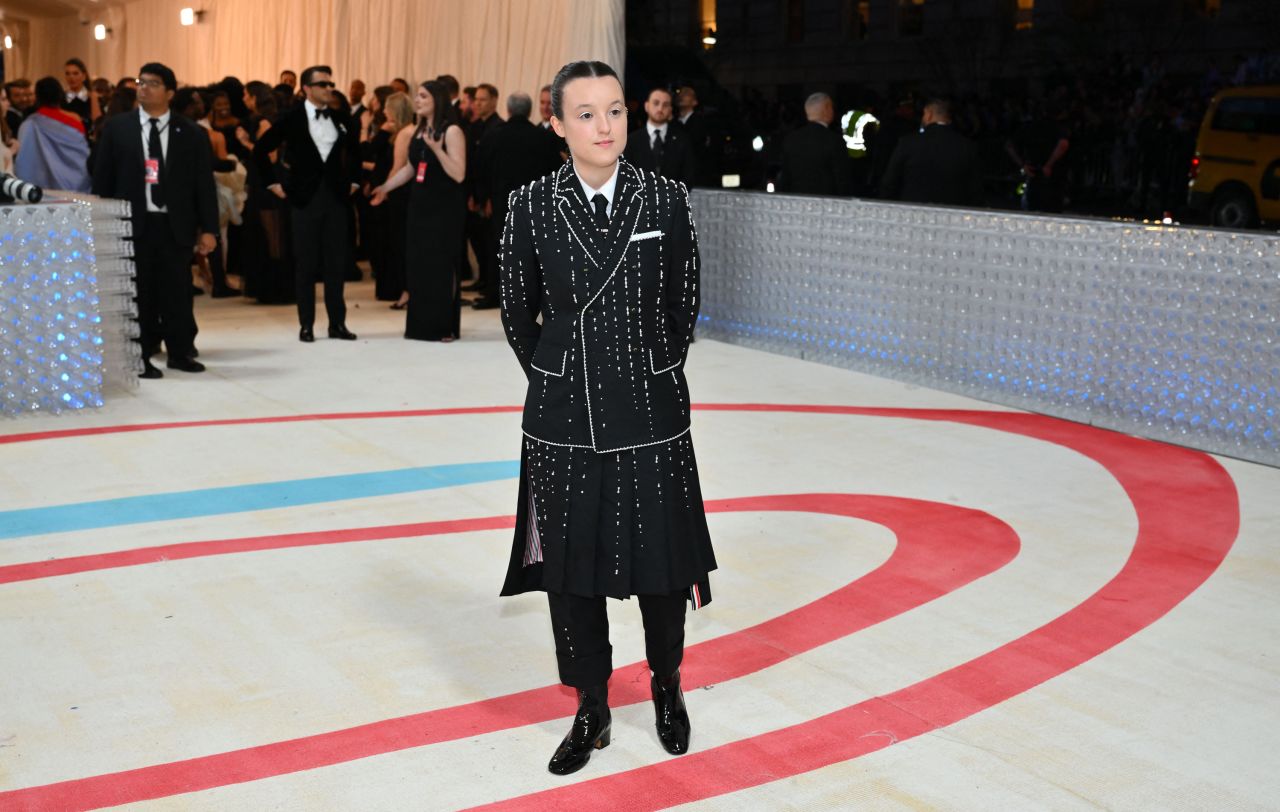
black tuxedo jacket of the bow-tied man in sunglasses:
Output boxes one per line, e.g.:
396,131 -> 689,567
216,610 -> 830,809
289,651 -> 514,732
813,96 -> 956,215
253,102 -> 361,207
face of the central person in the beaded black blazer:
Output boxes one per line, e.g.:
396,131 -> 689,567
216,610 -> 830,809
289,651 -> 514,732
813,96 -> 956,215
552,76 -> 627,169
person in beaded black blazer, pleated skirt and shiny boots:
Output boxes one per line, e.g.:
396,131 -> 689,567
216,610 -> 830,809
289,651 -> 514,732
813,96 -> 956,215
500,61 -> 716,775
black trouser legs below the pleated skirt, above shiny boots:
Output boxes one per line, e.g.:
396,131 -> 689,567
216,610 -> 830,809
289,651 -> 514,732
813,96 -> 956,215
547,589 -> 689,689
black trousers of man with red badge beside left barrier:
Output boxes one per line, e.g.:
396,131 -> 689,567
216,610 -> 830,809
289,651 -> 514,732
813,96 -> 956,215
133,213 -> 196,360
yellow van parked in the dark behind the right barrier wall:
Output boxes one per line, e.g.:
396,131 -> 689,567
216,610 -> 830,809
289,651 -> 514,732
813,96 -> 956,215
1187,85 -> 1280,228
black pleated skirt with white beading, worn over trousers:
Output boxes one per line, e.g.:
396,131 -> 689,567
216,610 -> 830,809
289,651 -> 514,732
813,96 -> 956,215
502,433 -> 716,610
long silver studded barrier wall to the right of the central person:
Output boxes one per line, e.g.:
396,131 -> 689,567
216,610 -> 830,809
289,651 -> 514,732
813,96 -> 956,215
692,190 -> 1280,465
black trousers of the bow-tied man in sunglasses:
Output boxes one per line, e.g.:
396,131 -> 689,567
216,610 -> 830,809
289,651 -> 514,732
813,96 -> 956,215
293,186 -> 351,328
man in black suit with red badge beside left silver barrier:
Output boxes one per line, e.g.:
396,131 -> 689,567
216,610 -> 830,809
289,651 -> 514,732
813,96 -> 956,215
92,63 -> 218,378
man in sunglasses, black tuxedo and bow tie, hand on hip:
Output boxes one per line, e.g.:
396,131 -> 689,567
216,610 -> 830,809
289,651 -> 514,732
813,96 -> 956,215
253,65 -> 361,342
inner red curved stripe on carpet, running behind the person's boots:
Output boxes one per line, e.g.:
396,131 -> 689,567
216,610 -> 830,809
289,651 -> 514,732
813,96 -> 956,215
0,494 -> 1018,809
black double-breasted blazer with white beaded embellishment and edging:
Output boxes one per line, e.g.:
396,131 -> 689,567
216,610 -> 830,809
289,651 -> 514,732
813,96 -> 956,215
499,159 -> 699,452
